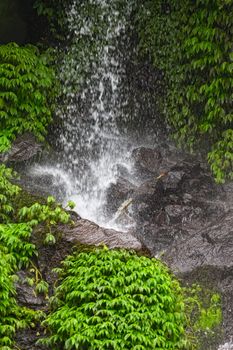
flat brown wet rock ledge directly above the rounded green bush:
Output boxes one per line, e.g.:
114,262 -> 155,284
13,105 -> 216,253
34,218 -> 145,284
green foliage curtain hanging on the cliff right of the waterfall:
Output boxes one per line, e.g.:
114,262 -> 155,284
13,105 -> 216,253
137,0 -> 233,182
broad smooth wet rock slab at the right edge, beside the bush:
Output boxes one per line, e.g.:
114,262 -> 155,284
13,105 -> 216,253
163,210 -> 233,338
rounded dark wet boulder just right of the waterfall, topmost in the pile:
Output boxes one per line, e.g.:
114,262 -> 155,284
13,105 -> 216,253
132,147 -> 162,178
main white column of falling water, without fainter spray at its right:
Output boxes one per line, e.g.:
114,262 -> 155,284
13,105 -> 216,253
30,0 -> 137,226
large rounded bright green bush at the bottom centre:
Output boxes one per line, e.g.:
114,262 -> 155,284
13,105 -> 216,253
41,249 -> 187,350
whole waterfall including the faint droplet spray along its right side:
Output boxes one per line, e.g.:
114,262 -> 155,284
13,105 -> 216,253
31,0 -> 161,230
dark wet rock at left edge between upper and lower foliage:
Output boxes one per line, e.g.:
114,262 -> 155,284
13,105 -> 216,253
0,133 -> 42,163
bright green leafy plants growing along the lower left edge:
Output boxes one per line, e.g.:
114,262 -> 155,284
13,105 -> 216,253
0,165 -> 72,350
